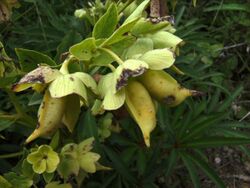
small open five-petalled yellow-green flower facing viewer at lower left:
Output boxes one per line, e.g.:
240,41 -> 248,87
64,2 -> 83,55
27,145 -> 60,174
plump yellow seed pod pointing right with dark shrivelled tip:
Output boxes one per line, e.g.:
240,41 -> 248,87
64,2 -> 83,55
139,70 -> 202,106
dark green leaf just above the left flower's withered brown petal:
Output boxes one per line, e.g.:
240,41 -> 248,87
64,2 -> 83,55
15,48 -> 56,72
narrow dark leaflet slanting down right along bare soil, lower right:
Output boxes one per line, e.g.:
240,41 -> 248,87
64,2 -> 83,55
182,152 -> 226,188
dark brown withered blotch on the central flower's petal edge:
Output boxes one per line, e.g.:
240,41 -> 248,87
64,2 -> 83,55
116,67 -> 146,91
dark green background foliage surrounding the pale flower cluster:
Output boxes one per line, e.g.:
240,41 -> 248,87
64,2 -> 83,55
0,0 -> 250,188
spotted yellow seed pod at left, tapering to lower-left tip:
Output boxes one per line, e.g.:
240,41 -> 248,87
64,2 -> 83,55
25,90 -> 66,144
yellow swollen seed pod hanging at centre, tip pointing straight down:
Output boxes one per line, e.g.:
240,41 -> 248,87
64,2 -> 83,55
125,80 -> 156,147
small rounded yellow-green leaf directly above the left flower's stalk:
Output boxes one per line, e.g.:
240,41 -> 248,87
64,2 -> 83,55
69,38 -> 96,61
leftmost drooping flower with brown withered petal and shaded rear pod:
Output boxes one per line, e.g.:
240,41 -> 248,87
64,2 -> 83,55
12,56 -> 98,132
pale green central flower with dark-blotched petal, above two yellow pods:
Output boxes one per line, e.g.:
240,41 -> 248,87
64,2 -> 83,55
98,49 -> 175,110
